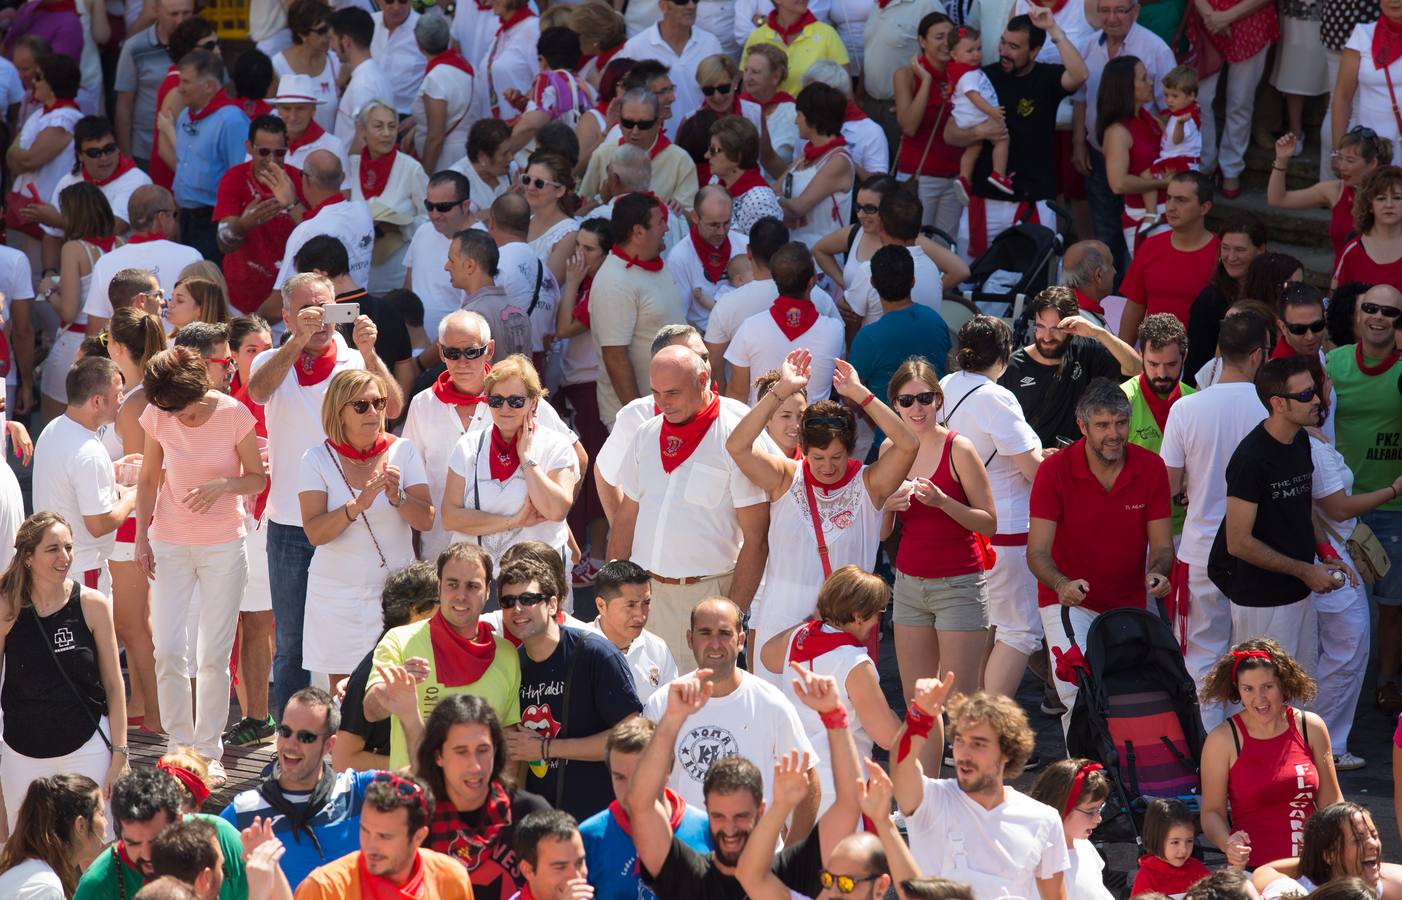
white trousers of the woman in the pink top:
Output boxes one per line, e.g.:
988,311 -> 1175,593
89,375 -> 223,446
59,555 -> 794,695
151,538 -> 248,760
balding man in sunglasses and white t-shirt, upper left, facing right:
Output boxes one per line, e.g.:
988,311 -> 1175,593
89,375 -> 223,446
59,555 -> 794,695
83,185 -> 200,335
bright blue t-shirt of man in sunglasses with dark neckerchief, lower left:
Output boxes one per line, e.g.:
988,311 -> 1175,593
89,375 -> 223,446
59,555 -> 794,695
219,771 -> 379,887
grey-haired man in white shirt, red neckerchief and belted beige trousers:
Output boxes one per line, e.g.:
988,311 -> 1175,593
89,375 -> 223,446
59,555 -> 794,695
608,346 -> 770,664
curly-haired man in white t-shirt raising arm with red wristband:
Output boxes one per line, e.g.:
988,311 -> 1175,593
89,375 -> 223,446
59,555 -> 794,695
890,676 -> 1065,900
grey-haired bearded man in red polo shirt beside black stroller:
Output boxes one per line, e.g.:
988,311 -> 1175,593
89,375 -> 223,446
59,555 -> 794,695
1028,379 -> 1173,729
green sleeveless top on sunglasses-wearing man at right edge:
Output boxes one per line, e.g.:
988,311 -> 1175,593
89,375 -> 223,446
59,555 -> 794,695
1325,343 -> 1402,512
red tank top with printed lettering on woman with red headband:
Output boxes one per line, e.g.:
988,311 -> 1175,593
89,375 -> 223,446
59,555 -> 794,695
1227,707 -> 1319,868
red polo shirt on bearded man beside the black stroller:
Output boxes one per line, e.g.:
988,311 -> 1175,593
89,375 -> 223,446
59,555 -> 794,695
1028,437 -> 1172,613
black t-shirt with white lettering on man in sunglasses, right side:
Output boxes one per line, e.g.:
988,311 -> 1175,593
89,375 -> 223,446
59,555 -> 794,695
1207,422 -> 1315,607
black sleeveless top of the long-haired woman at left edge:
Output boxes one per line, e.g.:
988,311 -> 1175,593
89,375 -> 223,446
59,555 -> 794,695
0,580 -> 107,758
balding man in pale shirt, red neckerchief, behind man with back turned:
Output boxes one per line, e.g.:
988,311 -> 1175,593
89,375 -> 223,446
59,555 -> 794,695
667,185 -> 750,331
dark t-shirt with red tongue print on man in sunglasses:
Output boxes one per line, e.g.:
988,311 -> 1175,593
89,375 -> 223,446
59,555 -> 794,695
520,627 -> 642,821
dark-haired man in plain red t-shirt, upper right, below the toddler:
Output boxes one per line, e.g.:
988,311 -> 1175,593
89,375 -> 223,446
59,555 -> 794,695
1120,172 -> 1217,346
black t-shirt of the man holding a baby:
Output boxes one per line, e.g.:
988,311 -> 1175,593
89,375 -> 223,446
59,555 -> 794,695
973,63 -> 1070,200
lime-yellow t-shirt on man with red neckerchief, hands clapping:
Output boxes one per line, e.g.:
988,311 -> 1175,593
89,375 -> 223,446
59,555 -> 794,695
366,617 -> 522,768
